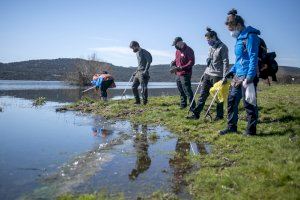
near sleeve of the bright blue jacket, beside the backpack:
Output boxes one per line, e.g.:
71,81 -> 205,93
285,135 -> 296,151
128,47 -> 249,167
246,34 -> 259,79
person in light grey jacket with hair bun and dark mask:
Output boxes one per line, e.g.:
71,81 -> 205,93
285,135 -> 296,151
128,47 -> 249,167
187,28 -> 229,120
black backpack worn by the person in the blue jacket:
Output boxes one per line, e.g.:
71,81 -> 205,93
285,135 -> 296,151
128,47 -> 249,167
243,37 -> 278,81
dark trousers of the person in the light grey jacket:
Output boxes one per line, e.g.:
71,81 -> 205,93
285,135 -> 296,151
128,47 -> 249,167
193,74 -> 224,118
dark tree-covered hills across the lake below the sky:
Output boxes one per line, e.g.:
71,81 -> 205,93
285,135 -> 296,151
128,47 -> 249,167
0,58 -> 300,83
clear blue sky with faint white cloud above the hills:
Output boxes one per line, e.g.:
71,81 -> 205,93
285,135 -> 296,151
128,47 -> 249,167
0,0 -> 300,67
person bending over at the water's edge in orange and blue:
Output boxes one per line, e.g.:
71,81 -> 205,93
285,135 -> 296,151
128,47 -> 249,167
91,71 -> 116,101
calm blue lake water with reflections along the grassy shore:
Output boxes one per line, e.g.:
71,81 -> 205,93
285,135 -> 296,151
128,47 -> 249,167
0,80 -> 206,200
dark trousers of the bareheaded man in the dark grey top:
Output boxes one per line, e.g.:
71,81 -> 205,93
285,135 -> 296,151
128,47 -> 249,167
132,72 -> 150,102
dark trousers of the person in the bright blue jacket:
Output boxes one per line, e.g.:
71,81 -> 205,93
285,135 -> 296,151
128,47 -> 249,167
228,79 -> 258,134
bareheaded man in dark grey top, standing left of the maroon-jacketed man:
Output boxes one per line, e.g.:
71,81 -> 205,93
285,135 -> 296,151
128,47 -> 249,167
129,41 -> 152,105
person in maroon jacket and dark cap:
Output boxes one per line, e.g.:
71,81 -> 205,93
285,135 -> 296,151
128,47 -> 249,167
170,37 -> 196,109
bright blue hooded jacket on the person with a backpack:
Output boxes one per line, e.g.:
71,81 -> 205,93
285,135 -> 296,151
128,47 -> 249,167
230,26 -> 260,80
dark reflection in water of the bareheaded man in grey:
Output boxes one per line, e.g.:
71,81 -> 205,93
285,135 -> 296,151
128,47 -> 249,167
128,124 -> 151,180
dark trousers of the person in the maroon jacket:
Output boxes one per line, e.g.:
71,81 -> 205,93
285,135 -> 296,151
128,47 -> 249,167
176,75 -> 196,108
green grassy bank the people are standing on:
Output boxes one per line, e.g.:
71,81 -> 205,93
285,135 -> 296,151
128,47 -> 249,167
62,85 -> 300,199
